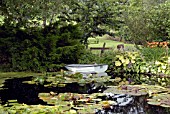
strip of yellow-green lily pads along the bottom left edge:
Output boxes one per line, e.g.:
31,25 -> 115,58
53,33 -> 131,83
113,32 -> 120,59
0,104 -> 79,114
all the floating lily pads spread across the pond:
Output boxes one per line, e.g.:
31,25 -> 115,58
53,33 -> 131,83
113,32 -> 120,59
0,71 -> 170,114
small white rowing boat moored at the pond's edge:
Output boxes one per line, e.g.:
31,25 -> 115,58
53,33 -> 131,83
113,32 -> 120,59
65,64 -> 108,73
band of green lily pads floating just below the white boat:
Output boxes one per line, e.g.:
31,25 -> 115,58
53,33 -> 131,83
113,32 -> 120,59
23,72 -> 114,87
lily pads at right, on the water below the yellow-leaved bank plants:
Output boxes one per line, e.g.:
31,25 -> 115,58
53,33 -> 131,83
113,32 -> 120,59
104,85 -> 170,107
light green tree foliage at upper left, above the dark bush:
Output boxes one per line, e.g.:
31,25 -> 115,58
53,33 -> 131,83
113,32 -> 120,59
1,0 -> 68,28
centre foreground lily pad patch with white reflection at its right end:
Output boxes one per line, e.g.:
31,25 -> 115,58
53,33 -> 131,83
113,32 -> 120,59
39,92 -> 133,114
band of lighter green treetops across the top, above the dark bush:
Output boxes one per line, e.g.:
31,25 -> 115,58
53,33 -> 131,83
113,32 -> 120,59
1,0 -> 170,44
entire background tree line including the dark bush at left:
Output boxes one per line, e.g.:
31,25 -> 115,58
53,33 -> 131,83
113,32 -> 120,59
0,0 -> 170,71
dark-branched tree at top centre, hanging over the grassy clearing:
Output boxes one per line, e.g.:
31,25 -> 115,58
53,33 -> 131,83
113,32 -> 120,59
60,0 -> 125,44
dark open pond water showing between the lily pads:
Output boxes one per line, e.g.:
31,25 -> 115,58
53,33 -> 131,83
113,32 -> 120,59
0,76 -> 170,114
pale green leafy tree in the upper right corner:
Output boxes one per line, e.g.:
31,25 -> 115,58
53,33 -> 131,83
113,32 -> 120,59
121,0 -> 170,44
